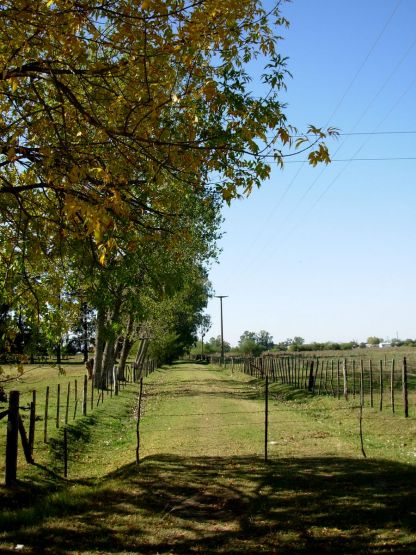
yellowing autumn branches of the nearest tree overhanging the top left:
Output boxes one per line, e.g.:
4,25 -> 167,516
0,0 -> 333,261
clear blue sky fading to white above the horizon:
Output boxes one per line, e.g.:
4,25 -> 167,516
207,0 -> 416,345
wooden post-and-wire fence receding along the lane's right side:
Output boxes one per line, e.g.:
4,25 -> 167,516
210,355 -> 416,417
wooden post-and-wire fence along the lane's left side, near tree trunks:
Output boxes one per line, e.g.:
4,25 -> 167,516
0,360 -> 157,486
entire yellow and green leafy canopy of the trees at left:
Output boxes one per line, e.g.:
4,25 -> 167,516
0,0 -> 335,374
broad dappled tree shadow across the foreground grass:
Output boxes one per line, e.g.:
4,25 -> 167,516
0,455 -> 416,555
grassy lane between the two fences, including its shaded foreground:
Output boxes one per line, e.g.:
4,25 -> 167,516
0,364 -> 416,555
